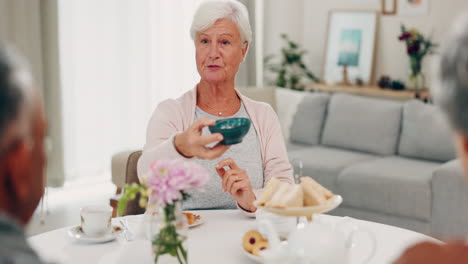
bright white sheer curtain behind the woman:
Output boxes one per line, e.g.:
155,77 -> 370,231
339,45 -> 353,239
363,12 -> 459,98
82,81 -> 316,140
58,0 -> 255,179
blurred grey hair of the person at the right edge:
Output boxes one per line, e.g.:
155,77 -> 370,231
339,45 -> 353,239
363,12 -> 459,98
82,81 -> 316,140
433,14 -> 468,136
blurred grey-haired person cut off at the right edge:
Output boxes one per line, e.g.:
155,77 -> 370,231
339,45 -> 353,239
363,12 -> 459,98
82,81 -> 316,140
396,14 -> 468,264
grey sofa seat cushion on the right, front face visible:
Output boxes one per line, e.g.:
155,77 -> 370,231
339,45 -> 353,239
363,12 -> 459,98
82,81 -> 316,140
338,156 -> 440,220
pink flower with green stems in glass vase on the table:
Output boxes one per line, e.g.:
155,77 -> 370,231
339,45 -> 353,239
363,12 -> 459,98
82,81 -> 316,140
118,160 -> 209,263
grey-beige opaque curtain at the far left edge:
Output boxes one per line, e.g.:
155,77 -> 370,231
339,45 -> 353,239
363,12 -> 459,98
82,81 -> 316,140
0,0 -> 64,187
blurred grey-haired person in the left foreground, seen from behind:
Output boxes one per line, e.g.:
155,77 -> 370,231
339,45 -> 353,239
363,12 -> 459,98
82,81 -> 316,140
0,44 -> 46,264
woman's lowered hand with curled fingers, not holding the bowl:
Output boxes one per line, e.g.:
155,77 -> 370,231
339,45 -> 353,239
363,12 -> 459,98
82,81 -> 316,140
216,158 -> 257,212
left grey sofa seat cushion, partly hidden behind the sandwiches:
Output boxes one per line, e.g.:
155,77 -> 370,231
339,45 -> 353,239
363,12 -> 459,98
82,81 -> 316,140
288,146 -> 377,193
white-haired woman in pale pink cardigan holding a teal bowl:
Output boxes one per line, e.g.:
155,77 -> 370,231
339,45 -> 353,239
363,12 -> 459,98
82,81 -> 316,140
138,0 -> 292,215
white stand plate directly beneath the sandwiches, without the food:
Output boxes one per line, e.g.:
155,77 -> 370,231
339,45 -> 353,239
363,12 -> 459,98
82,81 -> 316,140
255,195 -> 343,217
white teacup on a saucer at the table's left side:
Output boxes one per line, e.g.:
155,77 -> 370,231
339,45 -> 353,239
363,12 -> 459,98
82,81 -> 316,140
80,205 -> 112,237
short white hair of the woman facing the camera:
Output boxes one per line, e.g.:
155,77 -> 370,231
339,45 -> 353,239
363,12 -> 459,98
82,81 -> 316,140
190,0 -> 252,44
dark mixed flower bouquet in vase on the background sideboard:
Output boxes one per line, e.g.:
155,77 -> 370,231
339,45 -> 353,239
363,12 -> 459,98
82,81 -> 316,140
398,25 -> 437,88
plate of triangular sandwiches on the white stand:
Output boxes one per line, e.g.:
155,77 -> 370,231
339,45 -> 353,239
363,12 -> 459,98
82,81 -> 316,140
254,176 -> 343,218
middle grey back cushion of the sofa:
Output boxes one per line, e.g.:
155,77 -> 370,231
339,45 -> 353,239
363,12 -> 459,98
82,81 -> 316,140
322,94 -> 402,155
